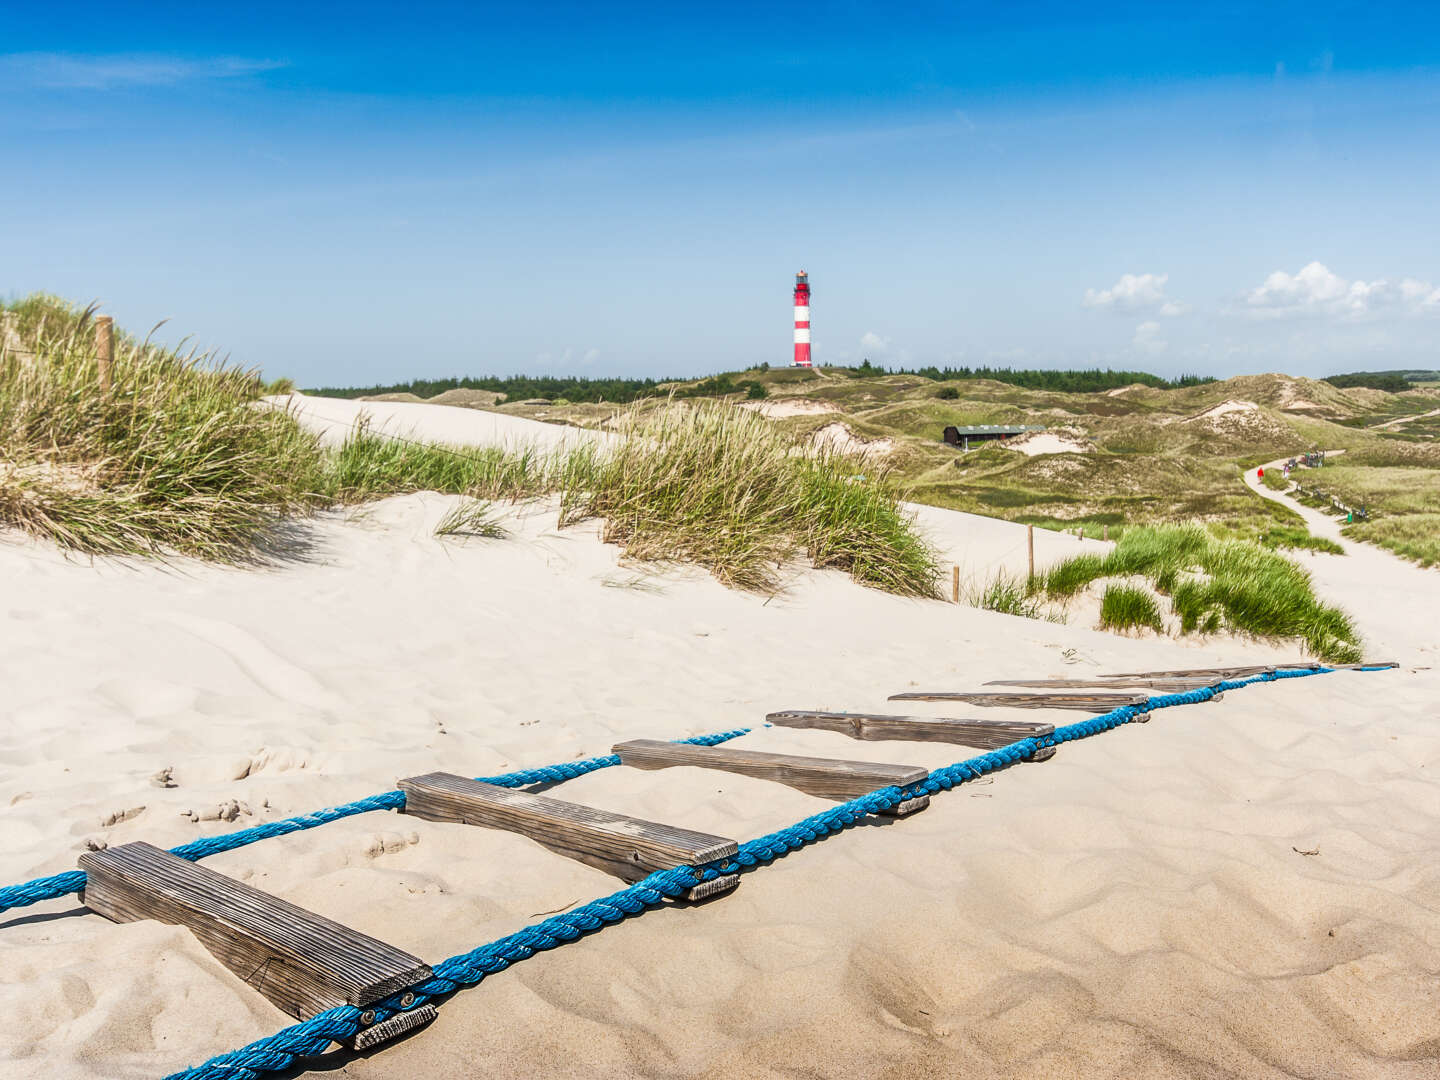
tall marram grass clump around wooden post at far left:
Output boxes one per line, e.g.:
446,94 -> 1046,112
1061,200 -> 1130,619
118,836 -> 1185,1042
0,297 -> 324,562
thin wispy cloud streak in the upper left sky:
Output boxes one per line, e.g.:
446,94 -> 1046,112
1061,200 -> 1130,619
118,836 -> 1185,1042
0,52 -> 287,91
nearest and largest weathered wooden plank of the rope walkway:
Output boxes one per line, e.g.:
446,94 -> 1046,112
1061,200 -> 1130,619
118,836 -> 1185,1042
81,842 -> 431,1020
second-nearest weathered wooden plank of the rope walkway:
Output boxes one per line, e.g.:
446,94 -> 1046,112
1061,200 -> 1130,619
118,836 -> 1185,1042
400,772 -> 739,900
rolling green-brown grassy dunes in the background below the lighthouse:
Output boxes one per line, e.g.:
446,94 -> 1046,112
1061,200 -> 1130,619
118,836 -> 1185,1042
309,367 -> 1440,562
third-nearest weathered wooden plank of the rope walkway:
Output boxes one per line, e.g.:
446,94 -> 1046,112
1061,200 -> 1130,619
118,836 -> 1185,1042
611,739 -> 930,815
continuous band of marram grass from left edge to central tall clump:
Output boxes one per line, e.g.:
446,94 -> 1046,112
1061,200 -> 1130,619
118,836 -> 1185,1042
0,297 -> 939,596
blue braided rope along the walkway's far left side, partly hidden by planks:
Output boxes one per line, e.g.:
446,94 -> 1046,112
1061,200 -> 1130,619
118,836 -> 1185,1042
0,727 -> 750,912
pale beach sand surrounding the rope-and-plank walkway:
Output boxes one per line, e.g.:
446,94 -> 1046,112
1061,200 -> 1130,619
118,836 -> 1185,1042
0,403 -> 1440,1080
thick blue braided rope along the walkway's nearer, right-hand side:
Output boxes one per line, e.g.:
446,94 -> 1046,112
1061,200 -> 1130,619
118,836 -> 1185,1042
166,668 -> 1381,1080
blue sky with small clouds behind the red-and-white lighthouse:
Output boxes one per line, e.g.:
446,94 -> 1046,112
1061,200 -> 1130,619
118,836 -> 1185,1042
0,0 -> 1440,384
